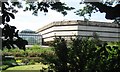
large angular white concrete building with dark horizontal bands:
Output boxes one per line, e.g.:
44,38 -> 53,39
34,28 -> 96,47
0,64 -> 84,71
37,20 -> 120,42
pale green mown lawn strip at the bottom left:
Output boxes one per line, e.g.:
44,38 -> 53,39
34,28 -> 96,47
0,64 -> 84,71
7,64 -> 48,70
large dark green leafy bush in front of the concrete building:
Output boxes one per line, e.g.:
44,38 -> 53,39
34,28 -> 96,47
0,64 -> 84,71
49,37 -> 120,72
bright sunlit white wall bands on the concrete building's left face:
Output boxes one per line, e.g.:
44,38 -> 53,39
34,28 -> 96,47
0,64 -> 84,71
40,26 -> 78,41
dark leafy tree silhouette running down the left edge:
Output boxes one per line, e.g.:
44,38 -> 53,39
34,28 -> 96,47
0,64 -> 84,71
2,2 -> 28,51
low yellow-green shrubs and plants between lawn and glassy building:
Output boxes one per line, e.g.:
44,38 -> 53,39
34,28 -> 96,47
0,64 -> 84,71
2,45 -> 53,65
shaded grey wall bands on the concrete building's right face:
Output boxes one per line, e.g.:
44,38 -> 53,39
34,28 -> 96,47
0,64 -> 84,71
78,25 -> 120,41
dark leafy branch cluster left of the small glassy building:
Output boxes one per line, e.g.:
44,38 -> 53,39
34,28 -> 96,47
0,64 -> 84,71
2,24 -> 28,51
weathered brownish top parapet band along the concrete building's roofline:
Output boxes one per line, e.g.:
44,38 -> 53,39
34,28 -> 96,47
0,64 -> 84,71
37,20 -> 120,32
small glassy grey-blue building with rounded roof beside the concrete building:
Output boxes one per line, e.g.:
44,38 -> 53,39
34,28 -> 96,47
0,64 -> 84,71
18,29 -> 42,45
